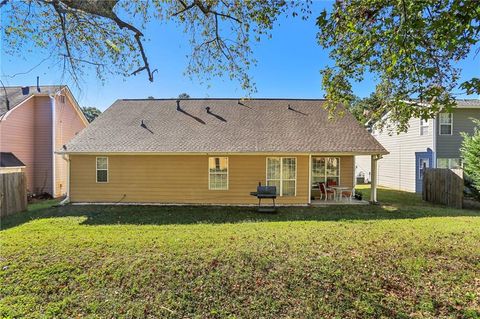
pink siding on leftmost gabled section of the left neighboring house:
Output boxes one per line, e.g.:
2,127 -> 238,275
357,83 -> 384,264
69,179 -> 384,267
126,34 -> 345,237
0,98 -> 35,191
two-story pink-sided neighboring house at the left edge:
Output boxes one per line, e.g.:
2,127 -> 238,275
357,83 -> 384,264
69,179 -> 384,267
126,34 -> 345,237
0,85 -> 88,197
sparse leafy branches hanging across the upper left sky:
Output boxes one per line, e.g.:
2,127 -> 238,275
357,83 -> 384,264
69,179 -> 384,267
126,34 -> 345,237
0,0 -> 310,90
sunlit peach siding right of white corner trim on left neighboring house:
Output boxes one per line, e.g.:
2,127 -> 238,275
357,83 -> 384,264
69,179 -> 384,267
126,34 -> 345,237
54,92 -> 86,197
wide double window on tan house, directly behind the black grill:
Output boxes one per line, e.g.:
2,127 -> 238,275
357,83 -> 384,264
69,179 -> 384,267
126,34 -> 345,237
267,157 -> 297,196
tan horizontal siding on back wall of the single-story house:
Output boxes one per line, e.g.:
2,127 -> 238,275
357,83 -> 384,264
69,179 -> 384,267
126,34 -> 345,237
70,155 -> 308,204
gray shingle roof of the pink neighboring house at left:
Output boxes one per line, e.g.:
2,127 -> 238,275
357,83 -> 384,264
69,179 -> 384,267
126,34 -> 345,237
0,85 -> 64,115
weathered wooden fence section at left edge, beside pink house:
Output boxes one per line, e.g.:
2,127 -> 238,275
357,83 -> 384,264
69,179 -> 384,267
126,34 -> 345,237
0,172 -> 27,218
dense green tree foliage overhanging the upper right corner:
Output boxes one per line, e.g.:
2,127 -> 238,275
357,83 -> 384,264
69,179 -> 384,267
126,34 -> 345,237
317,0 -> 480,130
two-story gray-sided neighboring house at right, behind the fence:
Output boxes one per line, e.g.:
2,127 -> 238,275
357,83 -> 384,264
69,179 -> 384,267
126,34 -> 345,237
355,100 -> 480,192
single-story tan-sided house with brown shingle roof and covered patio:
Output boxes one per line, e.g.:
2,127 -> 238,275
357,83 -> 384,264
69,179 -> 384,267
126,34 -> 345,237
60,98 -> 388,205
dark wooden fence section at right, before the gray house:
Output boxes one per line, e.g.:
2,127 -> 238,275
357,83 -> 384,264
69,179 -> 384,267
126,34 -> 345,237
422,168 -> 463,208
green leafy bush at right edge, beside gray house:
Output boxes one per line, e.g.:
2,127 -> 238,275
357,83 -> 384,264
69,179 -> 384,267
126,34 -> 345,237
460,120 -> 480,193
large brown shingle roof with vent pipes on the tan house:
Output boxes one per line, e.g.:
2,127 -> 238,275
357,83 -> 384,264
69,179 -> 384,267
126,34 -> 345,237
66,99 -> 387,154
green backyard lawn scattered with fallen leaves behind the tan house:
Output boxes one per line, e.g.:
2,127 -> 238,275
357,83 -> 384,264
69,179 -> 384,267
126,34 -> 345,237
0,189 -> 480,318
